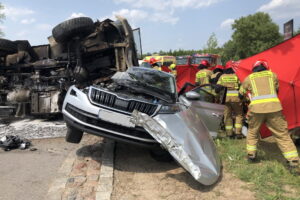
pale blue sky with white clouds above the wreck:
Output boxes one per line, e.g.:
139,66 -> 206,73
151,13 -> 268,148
0,0 -> 300,53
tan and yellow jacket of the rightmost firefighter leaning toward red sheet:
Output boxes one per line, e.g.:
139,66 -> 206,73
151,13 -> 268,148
239,70 -> 282,113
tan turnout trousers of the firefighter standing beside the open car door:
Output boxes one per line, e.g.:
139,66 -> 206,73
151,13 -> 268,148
224,102 -> 243,136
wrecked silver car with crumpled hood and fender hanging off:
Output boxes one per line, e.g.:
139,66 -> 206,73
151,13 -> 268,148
63,67 -> 226,185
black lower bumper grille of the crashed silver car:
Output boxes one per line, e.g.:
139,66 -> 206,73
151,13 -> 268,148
66,104 -> 154,141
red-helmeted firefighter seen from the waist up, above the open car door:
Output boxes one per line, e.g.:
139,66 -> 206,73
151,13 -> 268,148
195,60 -> 212,85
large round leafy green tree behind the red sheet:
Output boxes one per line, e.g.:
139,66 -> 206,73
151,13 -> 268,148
223,12 -> 283,59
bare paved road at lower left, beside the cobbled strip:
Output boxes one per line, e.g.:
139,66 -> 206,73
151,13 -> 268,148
0,138 -> 77,200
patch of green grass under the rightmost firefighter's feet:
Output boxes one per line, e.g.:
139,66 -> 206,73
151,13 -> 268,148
216,136 -> 300,200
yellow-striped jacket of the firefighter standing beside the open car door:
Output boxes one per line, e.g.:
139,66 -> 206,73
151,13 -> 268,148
217,74 -> 241,102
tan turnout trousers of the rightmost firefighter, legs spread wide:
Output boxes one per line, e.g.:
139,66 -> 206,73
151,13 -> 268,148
247,111 -> 299,161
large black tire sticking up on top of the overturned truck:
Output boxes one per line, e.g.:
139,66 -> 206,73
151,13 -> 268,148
52,17 -> 95,43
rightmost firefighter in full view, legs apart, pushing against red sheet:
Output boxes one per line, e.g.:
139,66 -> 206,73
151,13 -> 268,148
240,60 -> 300,173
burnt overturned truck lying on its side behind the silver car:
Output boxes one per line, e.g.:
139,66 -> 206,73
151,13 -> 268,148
0,17 -> 138,117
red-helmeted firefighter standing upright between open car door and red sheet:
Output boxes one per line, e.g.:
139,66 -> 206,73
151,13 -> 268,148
217,61 -> 244,139
